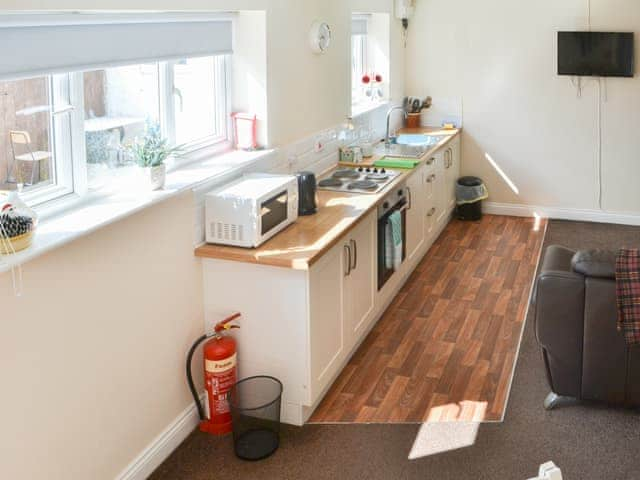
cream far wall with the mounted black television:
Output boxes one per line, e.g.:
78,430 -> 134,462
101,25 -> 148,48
405,0 -> 640,214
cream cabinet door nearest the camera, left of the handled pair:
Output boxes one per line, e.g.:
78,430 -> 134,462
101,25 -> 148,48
308,243 -> 348,402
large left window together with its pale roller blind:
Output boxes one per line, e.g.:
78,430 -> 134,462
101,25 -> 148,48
0,14 -> 231,205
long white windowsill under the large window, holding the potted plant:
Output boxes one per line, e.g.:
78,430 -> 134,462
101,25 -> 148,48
0,146 -> 273,272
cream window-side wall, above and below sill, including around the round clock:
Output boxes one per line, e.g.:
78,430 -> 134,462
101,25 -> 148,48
0,0 -> 404,480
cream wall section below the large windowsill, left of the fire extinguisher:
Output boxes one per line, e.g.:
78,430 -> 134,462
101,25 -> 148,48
0,193 -> 203,480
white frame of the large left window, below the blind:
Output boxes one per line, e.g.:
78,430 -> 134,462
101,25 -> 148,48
14,54 -> 231,208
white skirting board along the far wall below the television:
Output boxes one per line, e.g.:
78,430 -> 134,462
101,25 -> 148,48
482,202 -> 640,225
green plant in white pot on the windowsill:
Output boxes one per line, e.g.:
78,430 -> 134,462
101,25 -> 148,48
126,125 -> 183,190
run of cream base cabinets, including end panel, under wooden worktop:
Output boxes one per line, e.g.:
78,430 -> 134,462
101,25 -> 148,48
203,133 -> 460,425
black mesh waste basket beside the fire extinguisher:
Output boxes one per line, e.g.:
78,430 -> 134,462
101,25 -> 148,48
228,376 -> 282,460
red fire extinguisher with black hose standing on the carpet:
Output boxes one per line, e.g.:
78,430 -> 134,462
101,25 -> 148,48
187,313 -> 240,435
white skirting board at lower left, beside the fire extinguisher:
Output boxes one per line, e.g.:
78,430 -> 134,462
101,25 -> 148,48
116,394 -> 204,480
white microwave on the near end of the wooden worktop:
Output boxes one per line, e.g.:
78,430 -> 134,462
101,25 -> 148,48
205,173 -> 298,248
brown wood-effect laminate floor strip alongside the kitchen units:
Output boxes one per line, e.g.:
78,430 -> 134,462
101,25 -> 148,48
309,215 -> 546,423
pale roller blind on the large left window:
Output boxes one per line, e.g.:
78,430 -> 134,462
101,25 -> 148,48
0,13 -> 233,80
